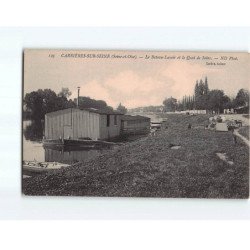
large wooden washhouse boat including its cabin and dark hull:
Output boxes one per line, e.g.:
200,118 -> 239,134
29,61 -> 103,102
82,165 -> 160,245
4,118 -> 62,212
43,108 -> 123,148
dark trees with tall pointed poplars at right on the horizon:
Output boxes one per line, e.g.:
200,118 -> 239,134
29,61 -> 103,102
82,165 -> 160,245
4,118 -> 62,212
163,77 -> 249,113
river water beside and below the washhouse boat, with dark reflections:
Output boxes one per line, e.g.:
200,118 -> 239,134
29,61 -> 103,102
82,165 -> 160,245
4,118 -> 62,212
23,121 -> 108,164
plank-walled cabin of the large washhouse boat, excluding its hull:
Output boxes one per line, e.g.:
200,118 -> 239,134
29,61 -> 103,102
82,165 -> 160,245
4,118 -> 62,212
45,108 -> 122,140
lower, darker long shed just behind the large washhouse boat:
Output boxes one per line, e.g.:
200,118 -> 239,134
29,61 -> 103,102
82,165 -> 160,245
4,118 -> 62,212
121,115 -> 150,134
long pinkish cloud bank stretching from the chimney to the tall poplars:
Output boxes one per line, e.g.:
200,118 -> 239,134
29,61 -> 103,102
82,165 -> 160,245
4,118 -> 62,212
73,62 -> 219,108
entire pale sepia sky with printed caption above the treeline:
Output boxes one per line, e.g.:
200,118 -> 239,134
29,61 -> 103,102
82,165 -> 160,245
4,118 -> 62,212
24,50 -> 250,108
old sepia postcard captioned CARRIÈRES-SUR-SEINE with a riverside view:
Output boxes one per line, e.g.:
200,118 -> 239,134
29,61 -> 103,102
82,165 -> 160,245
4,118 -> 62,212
22,49 -> 250,199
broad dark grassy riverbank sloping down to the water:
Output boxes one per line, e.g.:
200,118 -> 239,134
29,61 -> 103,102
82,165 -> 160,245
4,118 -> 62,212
23,115 -> 249,198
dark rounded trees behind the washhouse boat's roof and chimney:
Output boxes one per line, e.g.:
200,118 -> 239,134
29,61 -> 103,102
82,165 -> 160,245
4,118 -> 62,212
23,88 -> 127,120
